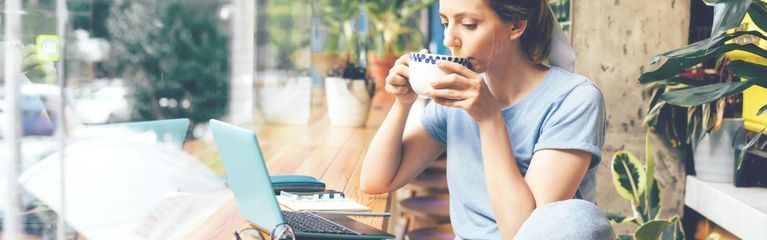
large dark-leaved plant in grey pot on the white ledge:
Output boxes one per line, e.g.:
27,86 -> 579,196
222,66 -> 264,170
639,0 -> 767,184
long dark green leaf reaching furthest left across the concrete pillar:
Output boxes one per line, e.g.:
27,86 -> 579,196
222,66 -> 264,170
639,31 -> 767,84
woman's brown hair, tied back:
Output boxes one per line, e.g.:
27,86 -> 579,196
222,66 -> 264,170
487,0 -> 554,63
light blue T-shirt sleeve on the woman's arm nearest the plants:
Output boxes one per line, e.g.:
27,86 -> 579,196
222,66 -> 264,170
535,81 -> 606,168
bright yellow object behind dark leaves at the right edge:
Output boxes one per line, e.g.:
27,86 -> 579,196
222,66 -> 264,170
725,0 -> 767,132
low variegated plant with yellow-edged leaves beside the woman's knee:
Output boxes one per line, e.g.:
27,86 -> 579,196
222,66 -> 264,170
607,131 -> 685,240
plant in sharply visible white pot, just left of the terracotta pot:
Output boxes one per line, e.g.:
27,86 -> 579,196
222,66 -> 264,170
312,0 -> 374,127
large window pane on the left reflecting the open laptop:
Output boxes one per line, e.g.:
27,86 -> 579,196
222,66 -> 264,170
0,0 -> 238,239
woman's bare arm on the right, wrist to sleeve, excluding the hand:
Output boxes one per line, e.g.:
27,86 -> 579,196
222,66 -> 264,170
479,114 -> 591,236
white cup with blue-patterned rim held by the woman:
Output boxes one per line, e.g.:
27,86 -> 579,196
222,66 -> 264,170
408,52 -> 469,96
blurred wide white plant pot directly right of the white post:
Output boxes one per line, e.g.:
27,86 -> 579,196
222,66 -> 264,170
257,73 -> 312,125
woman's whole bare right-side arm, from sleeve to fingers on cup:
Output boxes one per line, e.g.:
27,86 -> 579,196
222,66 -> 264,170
426,62 -> 591,239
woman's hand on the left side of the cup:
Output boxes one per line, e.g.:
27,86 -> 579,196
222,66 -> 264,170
384,54 -> 418,105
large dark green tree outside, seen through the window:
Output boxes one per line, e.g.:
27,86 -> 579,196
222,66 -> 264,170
107,0 -> 229,134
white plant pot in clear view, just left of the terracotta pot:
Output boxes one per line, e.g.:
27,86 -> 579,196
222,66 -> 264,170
325,77 -> 371,127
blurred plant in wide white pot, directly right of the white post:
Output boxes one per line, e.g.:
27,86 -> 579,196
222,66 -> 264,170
256,0 -> 311,124
